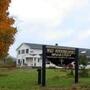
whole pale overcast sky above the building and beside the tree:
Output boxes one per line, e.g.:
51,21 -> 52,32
9,0 -> 90,56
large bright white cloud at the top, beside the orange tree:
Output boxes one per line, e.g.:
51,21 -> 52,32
9,0 -> 88,26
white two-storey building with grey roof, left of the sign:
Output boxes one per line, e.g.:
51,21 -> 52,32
16,43 -> 55,67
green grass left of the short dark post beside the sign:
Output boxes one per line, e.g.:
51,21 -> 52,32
0,70 -> 37,90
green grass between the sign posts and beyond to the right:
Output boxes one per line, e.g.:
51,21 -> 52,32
47,70 -> 90,88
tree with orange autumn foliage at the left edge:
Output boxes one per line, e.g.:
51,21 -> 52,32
0,0 -> 16,59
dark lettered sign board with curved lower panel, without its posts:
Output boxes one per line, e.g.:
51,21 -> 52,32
46,46 -> 75,66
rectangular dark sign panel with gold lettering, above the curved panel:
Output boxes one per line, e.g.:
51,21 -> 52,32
46,46 -> 75,59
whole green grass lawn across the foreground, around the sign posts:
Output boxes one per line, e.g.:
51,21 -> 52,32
0,69 -> 90,90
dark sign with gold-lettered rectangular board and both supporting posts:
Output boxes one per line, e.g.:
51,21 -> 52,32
41,45 -> 79,86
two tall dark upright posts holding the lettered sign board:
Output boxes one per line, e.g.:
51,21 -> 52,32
41,45 -> 79,87
